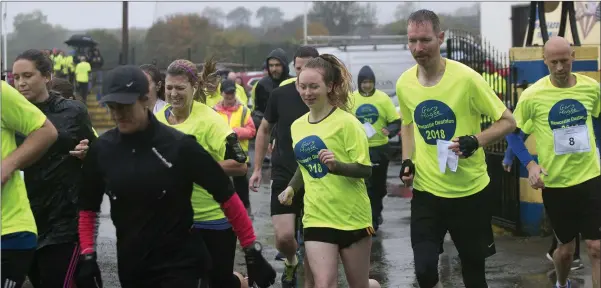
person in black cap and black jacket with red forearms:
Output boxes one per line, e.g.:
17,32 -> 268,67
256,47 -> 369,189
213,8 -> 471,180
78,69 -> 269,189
77,62 -> 275,288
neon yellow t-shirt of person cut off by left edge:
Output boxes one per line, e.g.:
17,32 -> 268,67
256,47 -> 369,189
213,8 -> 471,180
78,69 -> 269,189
1,81 -> 46,235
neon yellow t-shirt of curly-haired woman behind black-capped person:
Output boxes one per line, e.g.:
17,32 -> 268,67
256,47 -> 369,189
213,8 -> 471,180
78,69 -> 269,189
155,101 -> 234,221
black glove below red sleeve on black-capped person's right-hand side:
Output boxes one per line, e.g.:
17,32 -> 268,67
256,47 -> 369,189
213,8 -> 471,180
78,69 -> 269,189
244,242 -> 276,288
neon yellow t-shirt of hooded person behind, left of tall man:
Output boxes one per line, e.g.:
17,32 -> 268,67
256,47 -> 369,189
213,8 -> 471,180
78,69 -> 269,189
352,89 -> 401,147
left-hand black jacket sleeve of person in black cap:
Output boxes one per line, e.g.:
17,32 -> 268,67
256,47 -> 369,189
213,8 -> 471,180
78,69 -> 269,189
77,141 -> 106,212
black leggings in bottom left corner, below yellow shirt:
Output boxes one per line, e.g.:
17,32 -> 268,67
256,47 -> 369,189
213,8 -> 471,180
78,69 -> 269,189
0,249 -> 37,288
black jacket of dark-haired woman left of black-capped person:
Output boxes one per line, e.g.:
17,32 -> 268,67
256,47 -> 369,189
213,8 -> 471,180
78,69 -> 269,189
17,92 -> 96,249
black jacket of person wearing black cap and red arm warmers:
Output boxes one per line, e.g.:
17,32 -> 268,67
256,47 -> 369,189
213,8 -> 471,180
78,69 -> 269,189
79,112 -> 234,281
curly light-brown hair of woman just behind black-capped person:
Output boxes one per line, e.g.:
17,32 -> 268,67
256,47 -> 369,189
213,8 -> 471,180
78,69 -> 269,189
167,57 -> 220,103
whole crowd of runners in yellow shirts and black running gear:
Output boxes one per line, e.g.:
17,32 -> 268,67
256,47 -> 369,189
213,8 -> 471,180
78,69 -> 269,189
0,10 -> 601,288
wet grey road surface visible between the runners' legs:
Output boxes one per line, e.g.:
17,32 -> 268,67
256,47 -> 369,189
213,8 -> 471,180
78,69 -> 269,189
86,161 -> 592,288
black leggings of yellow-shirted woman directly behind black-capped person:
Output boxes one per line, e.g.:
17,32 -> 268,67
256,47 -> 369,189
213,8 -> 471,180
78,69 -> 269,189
197,228 -> 240,288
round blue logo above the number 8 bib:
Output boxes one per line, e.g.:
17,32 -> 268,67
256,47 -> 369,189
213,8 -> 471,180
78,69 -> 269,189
549,99 -> 588,130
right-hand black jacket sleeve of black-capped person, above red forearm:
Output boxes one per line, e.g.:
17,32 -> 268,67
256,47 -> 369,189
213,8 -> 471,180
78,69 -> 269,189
179,135 -> 235,203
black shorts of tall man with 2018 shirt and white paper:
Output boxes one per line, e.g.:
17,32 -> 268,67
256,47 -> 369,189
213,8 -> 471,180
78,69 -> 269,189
411,189 -> 496,259
